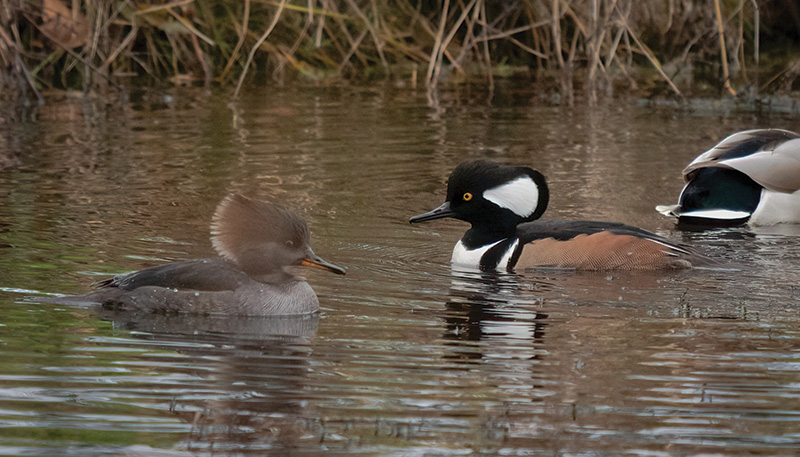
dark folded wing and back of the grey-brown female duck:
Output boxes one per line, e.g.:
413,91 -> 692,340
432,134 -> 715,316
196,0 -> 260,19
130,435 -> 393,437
95,259 -> 247,291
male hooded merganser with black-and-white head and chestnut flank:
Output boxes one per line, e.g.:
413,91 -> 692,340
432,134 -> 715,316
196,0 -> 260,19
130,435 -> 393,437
410,160 -> 710,271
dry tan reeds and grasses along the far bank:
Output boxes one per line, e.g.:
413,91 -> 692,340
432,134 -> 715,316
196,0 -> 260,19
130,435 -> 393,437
0,0 -> 788,102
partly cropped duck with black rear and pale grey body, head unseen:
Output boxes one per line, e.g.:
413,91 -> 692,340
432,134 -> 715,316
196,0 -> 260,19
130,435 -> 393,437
656,129 -> 800,227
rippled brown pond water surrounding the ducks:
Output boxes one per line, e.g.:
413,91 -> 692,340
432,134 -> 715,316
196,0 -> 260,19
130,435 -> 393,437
0,88 -> 800,456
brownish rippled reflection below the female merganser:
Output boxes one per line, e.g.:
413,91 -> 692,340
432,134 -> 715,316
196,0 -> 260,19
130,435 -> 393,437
103,311 -> 322,455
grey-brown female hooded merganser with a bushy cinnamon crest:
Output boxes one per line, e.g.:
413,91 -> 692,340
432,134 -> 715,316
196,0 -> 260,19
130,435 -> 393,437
55,194 -> 345,316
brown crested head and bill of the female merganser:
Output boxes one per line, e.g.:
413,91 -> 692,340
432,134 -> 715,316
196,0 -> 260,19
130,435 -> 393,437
211,194 -> 344,276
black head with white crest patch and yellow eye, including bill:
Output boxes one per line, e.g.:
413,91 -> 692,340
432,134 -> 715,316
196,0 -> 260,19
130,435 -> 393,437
411,160 -> 550,230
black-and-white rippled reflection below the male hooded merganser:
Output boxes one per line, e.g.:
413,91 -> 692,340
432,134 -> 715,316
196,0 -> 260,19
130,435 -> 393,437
442,270 -> 551,442
